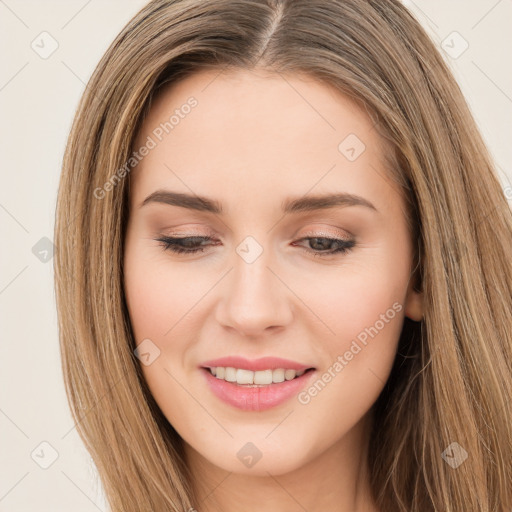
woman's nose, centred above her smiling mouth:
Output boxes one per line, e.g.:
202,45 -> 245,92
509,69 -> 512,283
216,247 -> 293,337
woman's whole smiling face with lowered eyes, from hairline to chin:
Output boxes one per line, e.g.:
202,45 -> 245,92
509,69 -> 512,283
124,67 -> 422,475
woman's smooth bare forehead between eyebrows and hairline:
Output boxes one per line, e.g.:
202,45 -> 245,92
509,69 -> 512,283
130,66 -> 400,216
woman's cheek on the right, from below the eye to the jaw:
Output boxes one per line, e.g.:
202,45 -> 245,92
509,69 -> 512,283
292,248 -> 408,406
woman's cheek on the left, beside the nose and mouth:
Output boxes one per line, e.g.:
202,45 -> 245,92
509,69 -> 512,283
124,250 -> 208,425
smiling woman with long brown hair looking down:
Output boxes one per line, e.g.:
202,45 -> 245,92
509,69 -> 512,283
55,0 -> 512,512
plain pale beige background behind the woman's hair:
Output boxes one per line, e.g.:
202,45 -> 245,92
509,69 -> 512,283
0,0 -> 512,512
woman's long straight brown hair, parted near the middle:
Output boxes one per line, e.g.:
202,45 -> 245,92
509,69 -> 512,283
54,0 -> 512,512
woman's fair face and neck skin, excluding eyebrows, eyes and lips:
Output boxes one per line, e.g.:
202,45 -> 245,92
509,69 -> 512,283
124,70 -> 422,512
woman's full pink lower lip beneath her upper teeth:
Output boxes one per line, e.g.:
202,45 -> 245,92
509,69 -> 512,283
202,368 -> 315,411
